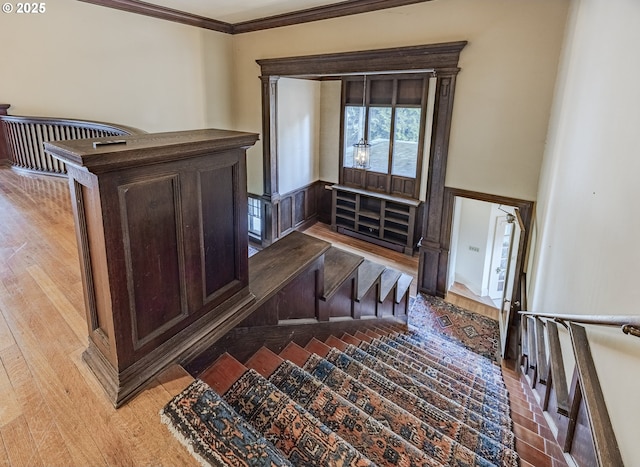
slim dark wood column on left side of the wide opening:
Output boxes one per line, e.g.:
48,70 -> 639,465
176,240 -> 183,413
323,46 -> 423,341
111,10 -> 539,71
260,76 -> 280,246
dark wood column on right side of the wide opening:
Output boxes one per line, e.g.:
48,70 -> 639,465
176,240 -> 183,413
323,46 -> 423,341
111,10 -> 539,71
418,68 -> 459,297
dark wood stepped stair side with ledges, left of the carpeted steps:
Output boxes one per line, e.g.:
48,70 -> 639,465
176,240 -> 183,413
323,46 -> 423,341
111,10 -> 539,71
182,232 -> 413,376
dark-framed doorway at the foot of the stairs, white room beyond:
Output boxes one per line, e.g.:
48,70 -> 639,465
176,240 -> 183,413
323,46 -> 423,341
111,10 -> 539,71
443,188 -> 533,358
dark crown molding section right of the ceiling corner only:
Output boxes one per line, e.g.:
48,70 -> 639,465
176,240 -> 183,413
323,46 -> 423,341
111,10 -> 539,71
233,0 -> 438,34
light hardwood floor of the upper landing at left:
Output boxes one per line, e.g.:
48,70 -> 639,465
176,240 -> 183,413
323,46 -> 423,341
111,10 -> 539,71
0,168 -> 198,467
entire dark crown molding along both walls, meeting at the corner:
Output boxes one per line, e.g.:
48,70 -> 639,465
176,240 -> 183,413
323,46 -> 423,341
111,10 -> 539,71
79,0 -> 431,34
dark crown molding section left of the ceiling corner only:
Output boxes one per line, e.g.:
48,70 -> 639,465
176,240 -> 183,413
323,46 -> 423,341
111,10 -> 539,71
79,0 -> 233,34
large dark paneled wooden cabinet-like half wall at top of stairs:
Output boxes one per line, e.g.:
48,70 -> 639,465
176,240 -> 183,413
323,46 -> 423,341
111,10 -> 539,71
46,130 -> 257,406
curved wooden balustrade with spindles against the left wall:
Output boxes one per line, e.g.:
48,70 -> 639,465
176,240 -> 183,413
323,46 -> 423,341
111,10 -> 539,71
0,104 -> 146,176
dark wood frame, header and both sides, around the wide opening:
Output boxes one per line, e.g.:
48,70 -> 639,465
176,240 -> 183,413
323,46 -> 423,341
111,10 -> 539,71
257,41 -> 467,250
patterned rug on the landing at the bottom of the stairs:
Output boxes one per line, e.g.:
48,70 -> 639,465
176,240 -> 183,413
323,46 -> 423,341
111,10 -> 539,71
409,294 -> 500,362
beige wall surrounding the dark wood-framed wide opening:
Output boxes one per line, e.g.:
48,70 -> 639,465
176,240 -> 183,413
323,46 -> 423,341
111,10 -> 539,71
234,0 -> 569,199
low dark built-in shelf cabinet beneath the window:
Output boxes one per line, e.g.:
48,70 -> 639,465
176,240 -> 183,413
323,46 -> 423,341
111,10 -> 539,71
331,185 -> 420,255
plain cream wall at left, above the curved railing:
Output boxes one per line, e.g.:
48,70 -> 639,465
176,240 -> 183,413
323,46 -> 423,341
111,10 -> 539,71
0,0 -> 232,131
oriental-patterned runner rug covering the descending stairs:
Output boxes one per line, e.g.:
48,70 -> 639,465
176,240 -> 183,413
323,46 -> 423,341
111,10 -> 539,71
161,297 -> 519,467
